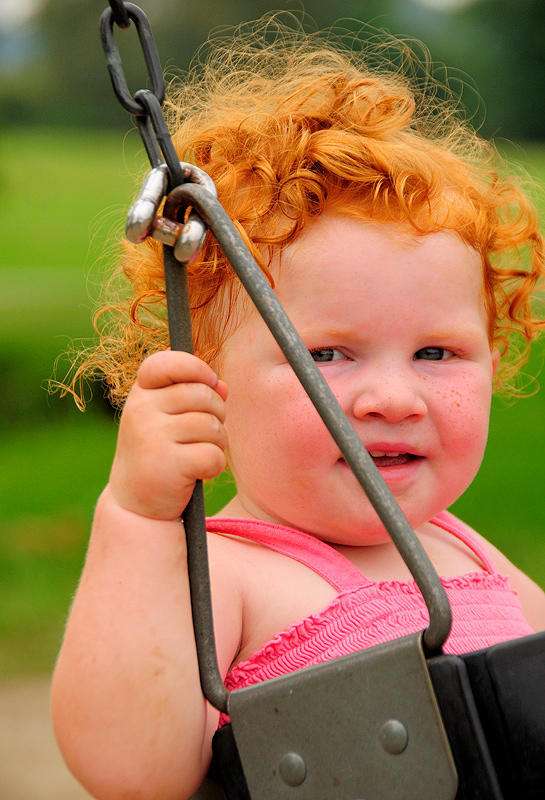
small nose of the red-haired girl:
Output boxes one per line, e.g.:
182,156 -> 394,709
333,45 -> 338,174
352,372 -> 428,424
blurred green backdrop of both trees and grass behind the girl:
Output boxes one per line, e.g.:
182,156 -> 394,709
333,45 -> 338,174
0,0 -> 545,678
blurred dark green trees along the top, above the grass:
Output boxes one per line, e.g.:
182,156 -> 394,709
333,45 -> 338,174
0,0 -> 545,140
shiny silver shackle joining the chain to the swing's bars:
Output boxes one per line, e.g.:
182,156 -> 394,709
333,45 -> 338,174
125,161 -> 218,264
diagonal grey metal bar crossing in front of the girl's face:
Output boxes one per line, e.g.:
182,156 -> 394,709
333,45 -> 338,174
169,183 -> 452,655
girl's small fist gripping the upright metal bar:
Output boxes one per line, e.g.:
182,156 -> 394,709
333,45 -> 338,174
110,350 -> 227,520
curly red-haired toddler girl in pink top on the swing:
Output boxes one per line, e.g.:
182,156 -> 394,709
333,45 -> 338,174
53,18 -> 545,800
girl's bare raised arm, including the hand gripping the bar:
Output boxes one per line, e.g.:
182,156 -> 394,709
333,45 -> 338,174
52,352 -> 241,800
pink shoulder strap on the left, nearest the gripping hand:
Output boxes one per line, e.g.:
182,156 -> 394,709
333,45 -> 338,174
206,517 -> 372,593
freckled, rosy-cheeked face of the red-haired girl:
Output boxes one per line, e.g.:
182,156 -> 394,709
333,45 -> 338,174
221,214 -> 498,545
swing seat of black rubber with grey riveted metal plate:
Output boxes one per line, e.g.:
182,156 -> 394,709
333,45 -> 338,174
204,633 -> 545,800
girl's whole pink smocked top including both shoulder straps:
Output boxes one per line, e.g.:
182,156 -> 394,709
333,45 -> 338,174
207,511 -> 534,724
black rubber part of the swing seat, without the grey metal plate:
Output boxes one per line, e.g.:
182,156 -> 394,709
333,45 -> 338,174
202,633 -> 545,800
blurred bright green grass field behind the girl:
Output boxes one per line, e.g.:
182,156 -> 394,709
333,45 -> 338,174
0,129 -> 545,677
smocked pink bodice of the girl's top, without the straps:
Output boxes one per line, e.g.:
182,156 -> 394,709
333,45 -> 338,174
225,572 -> 533,689
